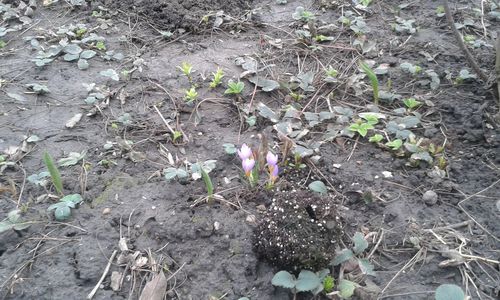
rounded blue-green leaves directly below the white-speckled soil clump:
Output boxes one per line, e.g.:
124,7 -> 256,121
271,269 -> 330,299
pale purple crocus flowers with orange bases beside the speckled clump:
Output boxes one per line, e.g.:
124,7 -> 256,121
238,144 -> 279,187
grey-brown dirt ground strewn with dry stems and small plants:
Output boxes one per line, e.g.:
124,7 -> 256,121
0,0 -> 500,300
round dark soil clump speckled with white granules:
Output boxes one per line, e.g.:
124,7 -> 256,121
255,190 -> 342,270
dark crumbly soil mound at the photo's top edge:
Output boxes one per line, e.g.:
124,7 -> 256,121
105,0 -> 253,31
